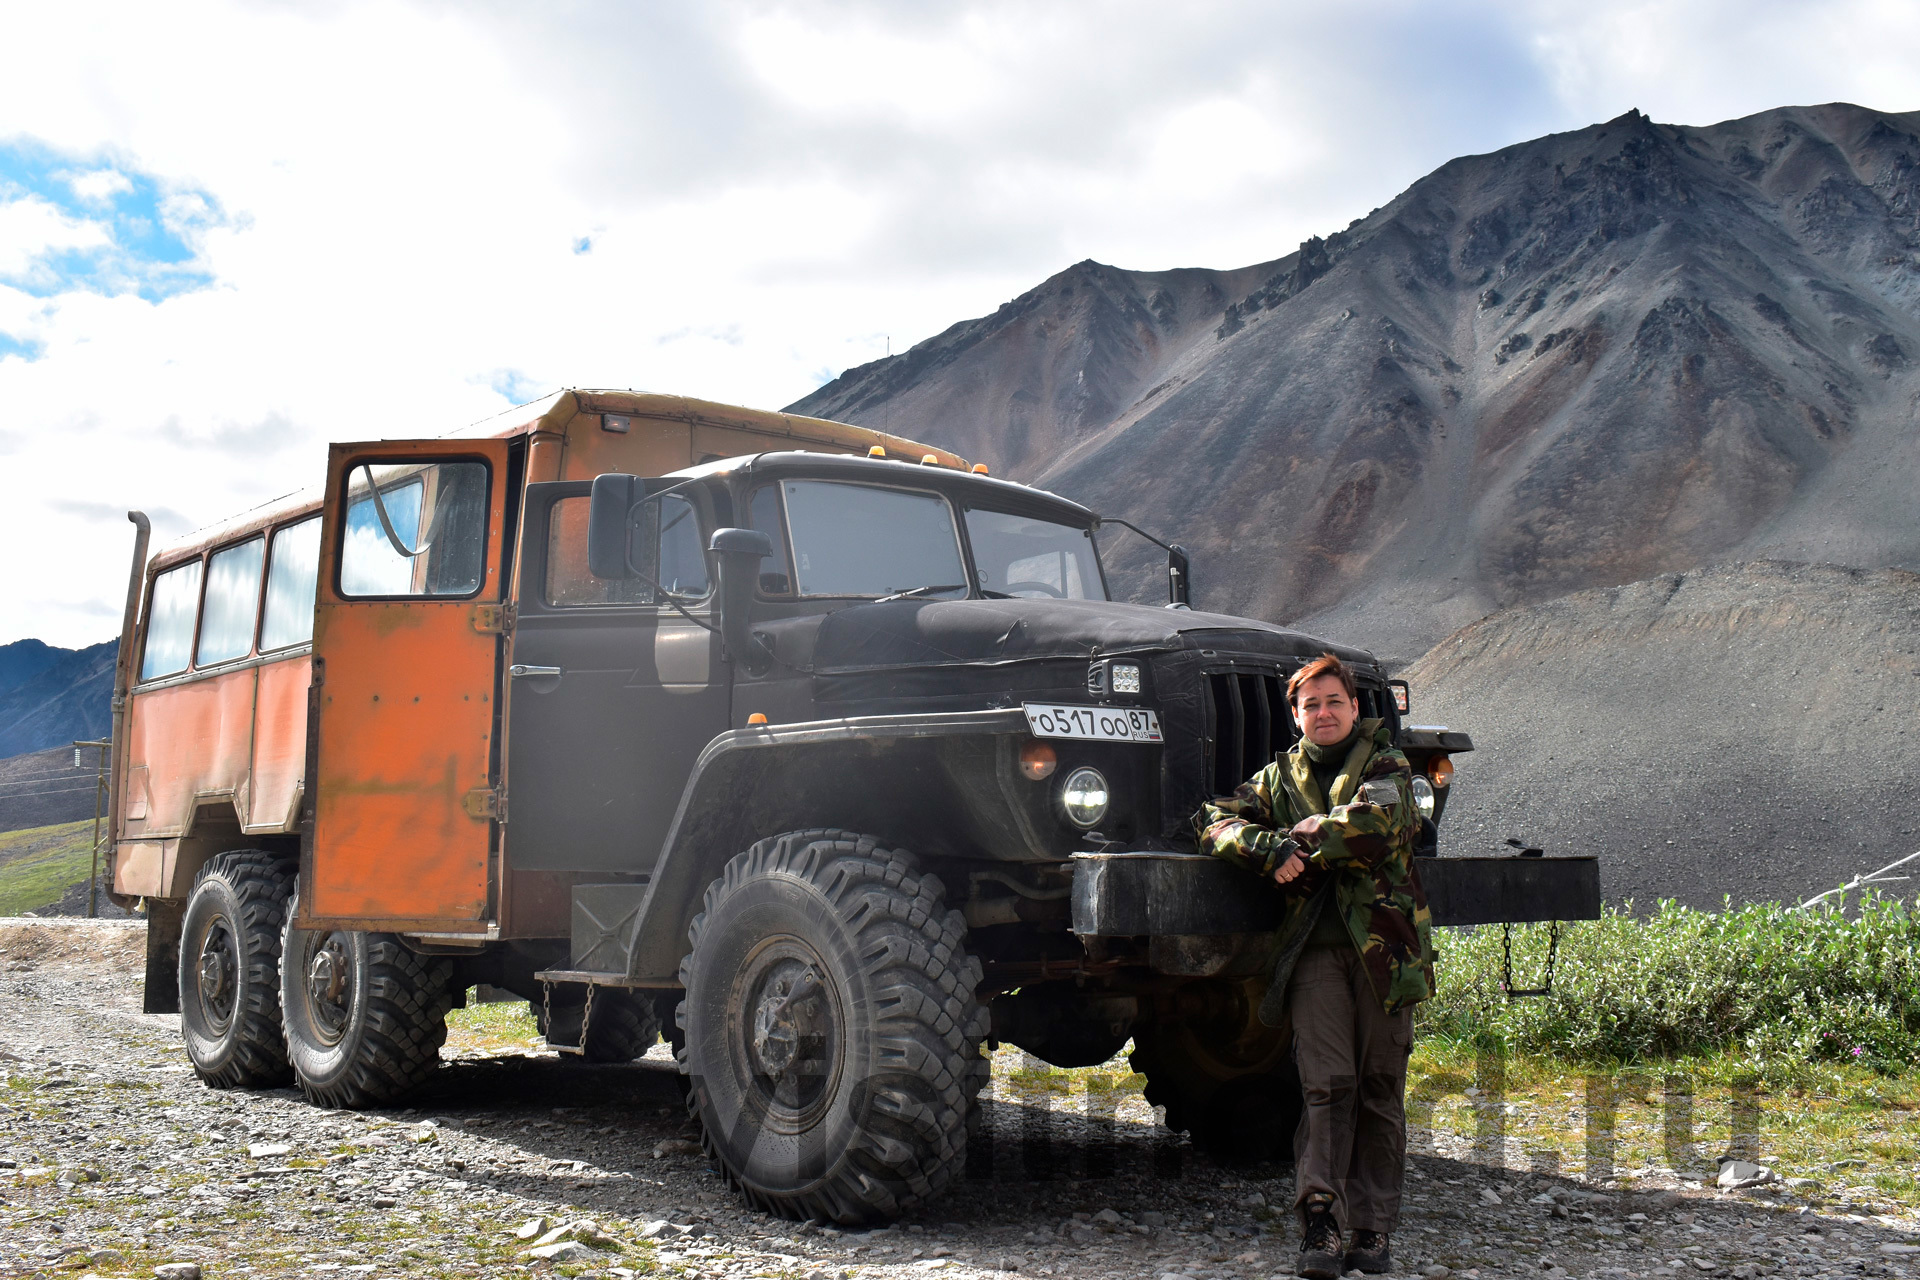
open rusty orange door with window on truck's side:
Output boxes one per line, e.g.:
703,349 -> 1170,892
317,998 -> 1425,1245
300,439 -> 509,931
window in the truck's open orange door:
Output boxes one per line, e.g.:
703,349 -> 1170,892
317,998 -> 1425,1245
340,462 -> 488,597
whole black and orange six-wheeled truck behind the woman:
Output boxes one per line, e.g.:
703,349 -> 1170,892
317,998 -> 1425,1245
113,391 -> 1597,1222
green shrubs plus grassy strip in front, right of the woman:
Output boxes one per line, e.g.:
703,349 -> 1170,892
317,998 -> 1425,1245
1407,894 -> 1920,1213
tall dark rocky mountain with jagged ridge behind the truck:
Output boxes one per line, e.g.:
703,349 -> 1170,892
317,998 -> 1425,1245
791,104 -> 1920,658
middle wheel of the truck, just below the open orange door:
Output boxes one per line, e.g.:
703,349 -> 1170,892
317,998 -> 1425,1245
280,896 -> 453,1107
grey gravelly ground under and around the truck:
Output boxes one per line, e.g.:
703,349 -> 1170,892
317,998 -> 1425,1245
0,921 -> 1920,1280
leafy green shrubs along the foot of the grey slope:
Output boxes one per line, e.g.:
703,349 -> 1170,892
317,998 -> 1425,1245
1419,894 -> 1920,1075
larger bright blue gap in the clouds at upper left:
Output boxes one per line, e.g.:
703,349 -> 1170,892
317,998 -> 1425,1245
0,138 -> 227,305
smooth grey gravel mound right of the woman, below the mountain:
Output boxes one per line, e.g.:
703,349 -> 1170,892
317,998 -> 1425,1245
1404,562 -> 1920,910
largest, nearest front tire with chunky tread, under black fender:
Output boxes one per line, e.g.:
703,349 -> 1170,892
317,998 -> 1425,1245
678,831 -> 987,1224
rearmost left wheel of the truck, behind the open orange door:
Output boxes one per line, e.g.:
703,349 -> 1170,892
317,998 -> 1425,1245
180,848 -> 294,1088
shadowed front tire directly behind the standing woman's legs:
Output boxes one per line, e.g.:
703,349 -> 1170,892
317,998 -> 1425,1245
1127,992 -> 1304,1163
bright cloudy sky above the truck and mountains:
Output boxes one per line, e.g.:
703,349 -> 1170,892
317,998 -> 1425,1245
0,0 -> 1920,645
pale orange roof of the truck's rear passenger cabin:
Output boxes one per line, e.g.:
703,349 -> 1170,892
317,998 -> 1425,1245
148,388 -> 968,568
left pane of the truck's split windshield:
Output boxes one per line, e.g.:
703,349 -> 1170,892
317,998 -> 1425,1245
780,480 -> 968,597
